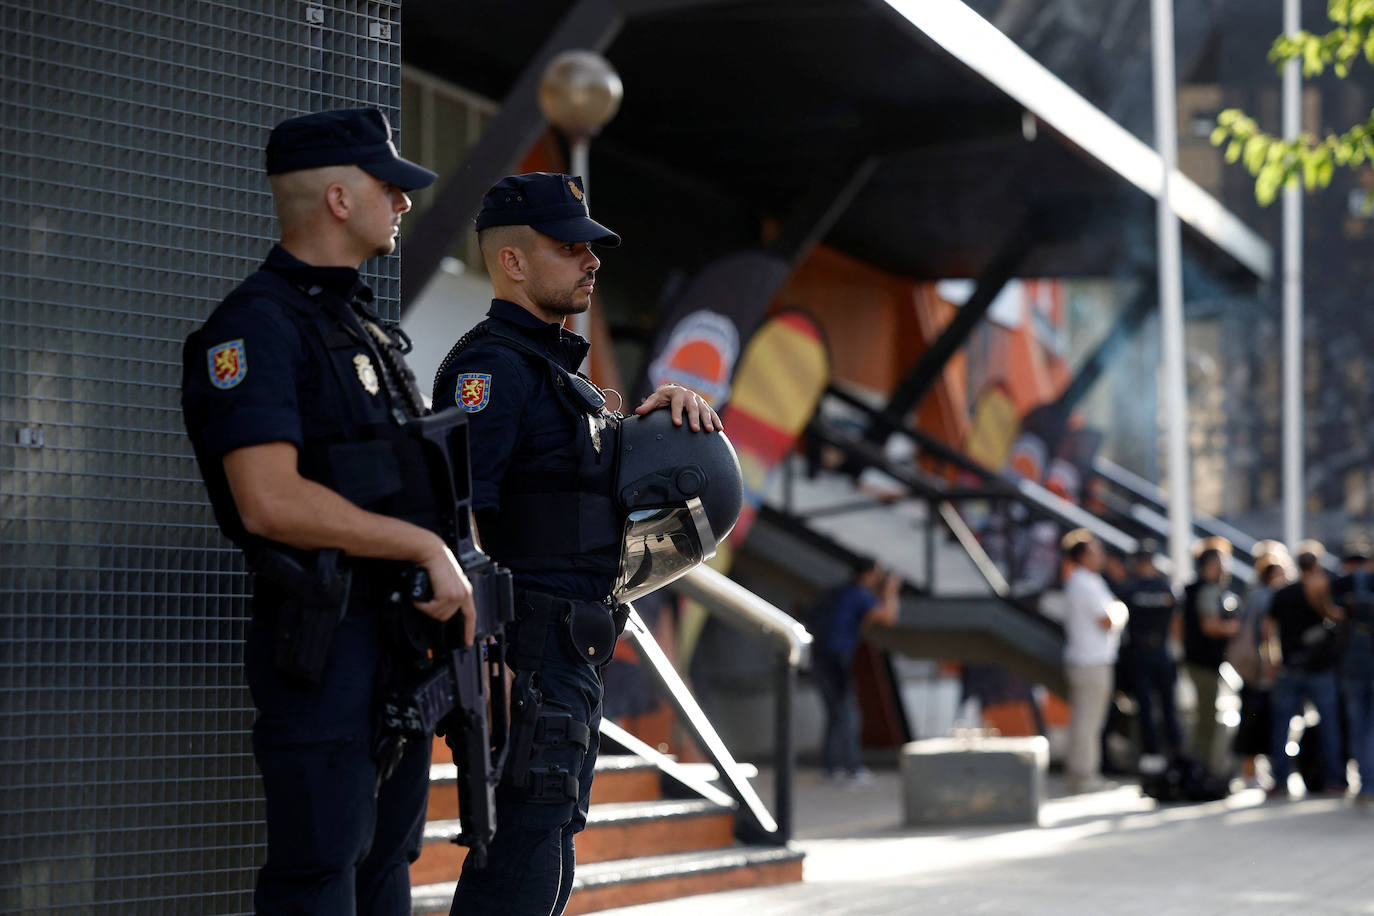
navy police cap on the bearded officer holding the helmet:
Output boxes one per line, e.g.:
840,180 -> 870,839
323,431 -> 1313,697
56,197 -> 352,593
477,172 -> 620,247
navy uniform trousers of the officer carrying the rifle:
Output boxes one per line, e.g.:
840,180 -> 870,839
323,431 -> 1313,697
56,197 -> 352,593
246,598 -> 430,916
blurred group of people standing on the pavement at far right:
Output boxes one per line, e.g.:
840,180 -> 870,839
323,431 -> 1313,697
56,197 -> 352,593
1062,529 -> 1374,810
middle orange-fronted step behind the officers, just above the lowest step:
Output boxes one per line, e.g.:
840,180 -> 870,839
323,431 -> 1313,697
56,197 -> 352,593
411,799 -> 735,886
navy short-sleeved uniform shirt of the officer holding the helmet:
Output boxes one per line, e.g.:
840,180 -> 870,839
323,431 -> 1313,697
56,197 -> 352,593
433,299 -> 614,600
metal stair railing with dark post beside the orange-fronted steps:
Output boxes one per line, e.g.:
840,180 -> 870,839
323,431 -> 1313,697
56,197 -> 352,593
625,566 -> 811,846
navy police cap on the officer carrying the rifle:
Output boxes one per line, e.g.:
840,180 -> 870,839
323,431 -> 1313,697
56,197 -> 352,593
267,108 -> 438,191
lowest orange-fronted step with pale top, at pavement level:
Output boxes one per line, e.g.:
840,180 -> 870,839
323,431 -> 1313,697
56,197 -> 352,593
411,836 -> 804,916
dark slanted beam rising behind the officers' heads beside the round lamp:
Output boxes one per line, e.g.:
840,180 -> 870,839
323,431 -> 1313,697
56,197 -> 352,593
401,0 -> 625,316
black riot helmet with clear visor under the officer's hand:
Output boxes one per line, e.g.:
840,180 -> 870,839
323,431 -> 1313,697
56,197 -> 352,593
614,409 -> 745,602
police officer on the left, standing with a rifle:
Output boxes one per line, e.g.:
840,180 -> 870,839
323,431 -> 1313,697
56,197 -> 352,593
181,108 -> 474,916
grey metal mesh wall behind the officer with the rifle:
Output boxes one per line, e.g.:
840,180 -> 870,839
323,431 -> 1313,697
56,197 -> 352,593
0,0 -> 400,915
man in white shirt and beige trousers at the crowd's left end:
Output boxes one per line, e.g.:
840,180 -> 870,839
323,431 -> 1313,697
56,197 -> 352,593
1063,529 -> 1127,792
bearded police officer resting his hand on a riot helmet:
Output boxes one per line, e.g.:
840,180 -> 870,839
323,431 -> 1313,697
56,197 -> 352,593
434,173 -> 738,916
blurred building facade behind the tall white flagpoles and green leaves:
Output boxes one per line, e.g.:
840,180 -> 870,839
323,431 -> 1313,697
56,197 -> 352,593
967,0 -> 1374,544
